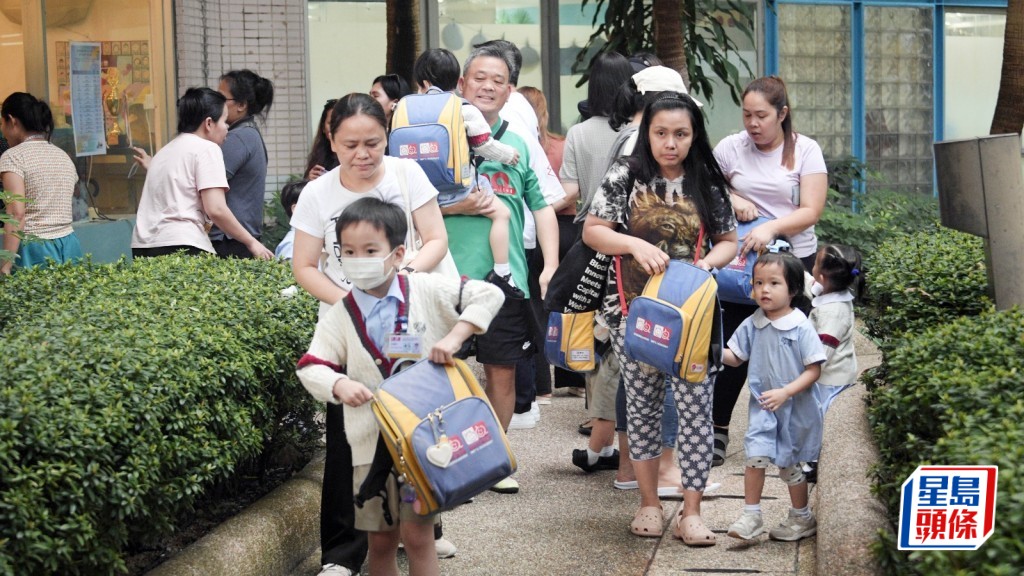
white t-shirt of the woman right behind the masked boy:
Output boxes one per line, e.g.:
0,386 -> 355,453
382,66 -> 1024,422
291,156 -> 438,318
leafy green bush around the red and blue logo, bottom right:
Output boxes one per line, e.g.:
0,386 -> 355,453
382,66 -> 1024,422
868,310 -> 1024,574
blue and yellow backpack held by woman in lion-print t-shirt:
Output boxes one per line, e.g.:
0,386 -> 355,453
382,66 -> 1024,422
615,258 -> 724,383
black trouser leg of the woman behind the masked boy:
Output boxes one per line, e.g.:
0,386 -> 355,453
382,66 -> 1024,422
321,404 -> 369,572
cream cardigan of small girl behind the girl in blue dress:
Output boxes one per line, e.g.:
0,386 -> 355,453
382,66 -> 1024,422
810,290 -> 857,386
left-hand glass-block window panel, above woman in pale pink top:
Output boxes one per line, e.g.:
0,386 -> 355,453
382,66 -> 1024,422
777,4 -> 851,159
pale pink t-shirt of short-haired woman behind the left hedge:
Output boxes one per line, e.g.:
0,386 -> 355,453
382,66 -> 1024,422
131,133 -> 227,252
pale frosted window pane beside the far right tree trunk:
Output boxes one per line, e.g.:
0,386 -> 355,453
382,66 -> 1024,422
943,8 -> 1007,139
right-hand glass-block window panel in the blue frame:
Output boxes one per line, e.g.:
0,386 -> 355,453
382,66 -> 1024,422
864,6 -> 933,194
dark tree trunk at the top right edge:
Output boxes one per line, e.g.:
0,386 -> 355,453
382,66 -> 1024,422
989,0 -> 1024,134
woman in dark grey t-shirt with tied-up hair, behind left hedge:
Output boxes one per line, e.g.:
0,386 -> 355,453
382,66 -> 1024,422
210,70 -> 273,258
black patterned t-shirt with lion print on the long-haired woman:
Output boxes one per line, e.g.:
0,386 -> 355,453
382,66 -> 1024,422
590,158 -> 736,327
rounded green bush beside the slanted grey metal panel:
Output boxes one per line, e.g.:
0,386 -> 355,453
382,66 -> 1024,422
863,228 -> 992,351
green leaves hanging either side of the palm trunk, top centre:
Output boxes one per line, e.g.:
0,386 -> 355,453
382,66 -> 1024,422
572,0 -> 755,105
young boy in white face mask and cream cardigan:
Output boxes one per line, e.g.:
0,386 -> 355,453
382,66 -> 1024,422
297,198 -> 505,574
